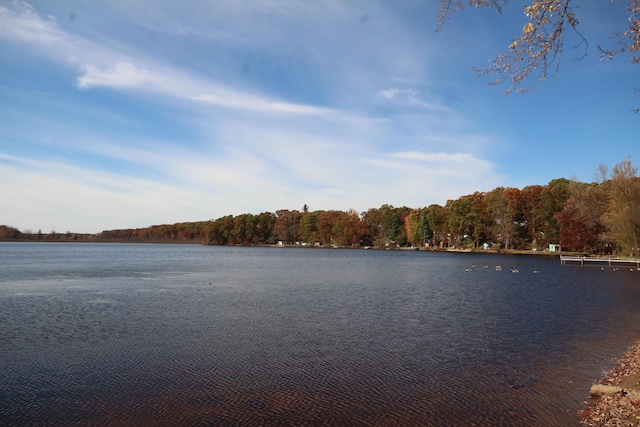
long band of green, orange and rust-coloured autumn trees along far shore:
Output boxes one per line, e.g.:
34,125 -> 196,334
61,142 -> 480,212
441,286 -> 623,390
0,158 -> 640,256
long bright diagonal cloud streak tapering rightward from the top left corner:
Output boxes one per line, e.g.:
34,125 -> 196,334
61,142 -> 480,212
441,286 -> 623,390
0,2 -> 348,116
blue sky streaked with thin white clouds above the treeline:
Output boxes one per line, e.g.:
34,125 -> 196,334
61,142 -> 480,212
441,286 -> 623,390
0,0 -> 640,233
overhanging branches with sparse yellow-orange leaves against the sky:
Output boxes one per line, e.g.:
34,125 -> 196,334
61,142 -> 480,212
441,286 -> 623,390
438,0 -> 640,93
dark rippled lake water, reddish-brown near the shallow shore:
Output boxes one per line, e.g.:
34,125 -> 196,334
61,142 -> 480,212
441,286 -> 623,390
0,243 -> 640,426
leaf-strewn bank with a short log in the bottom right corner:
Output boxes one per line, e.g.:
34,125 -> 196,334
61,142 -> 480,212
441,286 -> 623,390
580,343 -> 640,427
